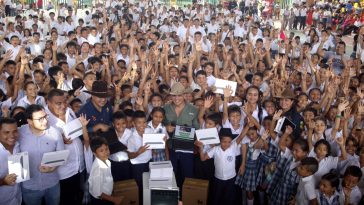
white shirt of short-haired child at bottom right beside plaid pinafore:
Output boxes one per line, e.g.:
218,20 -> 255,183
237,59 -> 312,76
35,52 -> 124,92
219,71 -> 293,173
296,175 -> 316,205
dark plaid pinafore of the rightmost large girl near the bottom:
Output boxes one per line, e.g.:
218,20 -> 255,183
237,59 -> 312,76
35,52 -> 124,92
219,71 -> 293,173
267,149 -> 300,205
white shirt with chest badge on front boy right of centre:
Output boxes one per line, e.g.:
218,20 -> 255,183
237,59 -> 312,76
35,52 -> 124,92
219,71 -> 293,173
207,141 -> 239,180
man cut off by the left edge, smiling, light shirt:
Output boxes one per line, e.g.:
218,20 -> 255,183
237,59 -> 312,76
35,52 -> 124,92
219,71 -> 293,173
0,118 -> 22,205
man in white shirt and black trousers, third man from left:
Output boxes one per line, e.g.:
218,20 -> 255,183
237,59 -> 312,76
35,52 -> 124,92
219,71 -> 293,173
45,89 -> 92,205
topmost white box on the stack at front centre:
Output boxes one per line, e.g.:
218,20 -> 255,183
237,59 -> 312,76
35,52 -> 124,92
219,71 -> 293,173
149,161 -> 173,179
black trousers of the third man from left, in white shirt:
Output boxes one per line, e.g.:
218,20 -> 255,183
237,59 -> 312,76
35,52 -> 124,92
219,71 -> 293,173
60,173 -> 83,205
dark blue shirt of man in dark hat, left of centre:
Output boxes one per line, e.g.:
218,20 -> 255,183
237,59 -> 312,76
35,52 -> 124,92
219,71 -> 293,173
78,99 -> 113,132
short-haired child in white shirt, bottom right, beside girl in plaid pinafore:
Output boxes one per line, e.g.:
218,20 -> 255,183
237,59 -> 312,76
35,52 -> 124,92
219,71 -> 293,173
295,157 -> 319,205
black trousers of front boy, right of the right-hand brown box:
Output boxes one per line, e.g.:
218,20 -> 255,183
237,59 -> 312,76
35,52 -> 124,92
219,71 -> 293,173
212,177 -> 236,205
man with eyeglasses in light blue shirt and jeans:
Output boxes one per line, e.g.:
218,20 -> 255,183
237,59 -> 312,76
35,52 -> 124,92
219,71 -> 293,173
19,105 -> 64,205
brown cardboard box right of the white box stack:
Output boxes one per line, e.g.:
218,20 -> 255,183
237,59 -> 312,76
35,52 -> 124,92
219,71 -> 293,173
182,178 -> 209,205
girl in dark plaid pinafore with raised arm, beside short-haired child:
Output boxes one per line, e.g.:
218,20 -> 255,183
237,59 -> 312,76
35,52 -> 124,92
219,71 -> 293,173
267,126 -> 309,205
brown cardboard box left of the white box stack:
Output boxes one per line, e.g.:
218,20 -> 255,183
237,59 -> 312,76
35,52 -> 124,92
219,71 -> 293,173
113,179 -> 139,205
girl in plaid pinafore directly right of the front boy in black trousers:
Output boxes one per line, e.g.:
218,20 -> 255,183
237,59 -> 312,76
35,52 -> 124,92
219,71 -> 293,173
235,123 -> 268,205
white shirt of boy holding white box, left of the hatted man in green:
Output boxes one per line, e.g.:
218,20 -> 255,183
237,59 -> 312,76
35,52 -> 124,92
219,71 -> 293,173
128,130 -> 152,164
